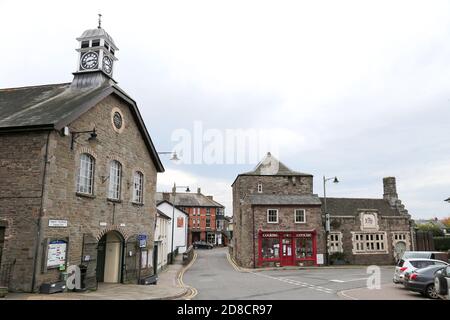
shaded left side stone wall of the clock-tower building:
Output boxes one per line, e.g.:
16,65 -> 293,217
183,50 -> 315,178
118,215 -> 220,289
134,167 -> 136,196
0,132 -> 48,291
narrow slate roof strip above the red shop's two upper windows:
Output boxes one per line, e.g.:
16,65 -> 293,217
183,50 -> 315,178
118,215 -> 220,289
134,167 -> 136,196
248,194 -> 322,206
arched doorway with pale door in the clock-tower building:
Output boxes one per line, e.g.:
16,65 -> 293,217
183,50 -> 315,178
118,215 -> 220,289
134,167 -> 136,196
97,231 -> 124,283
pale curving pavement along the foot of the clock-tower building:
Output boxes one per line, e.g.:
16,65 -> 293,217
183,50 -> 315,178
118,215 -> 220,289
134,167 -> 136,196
0,255 -> 194,300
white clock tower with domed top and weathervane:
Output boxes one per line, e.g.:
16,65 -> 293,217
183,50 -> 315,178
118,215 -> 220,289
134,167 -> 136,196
74,15 -> 119,85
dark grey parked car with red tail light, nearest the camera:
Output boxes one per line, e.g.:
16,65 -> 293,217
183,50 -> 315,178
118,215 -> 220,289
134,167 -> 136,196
403,265 -> 445,299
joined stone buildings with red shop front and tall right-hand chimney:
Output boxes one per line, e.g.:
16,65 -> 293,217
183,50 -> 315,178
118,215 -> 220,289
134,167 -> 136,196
232,153 -> 411,268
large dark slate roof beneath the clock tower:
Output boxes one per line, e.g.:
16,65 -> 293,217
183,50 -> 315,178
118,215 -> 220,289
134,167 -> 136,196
0,81 -> 164,172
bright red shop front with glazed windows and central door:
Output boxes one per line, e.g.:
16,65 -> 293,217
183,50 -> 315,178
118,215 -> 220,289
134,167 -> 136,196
258,231 -> 317,267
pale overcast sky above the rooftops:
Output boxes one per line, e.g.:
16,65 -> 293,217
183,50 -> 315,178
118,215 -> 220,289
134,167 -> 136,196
0,0 -> 450,218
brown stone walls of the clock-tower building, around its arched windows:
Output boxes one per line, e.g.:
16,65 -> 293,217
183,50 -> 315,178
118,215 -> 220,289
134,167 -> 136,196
0,95 -> 157,291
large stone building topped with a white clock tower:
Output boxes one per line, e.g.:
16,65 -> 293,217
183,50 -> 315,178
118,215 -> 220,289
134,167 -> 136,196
0,26 -> 164,292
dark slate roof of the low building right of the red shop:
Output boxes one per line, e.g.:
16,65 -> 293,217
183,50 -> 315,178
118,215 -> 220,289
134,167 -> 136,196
320,197 -> 401,216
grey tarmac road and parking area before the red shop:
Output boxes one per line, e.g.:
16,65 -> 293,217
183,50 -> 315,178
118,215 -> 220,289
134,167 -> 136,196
183,248 -> 432,300
